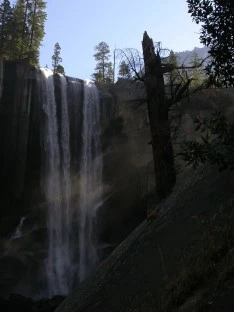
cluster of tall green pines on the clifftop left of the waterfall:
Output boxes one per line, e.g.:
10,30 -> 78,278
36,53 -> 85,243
0,0 -> 46,66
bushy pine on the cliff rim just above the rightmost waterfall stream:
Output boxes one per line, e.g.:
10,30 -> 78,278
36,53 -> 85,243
92,41 -> 114,83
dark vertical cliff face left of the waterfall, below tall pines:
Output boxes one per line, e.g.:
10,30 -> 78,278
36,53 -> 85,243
0,63 -> 40,230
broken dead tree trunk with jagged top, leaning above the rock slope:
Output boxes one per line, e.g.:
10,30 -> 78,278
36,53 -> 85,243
142,32 -> 176,201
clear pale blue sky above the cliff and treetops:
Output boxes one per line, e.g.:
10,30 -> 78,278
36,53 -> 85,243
40,0 -> 202,79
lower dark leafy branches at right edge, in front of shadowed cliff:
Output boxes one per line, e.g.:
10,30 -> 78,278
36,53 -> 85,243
179,112 -> 234,170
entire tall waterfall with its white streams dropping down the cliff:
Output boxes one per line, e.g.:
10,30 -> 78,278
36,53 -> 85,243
41,69 -> 102,296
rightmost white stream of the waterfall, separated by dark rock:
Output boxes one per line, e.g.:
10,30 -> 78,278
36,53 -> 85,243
79,81 -> 103,281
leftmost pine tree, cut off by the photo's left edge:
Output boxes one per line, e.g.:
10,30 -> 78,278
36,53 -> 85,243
0,0 -> 13,58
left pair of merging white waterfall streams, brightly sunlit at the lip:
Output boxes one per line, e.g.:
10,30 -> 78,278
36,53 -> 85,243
41,69 -> 71,296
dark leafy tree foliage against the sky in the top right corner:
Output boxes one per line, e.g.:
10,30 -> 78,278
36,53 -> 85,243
187,0 -> 234,86
